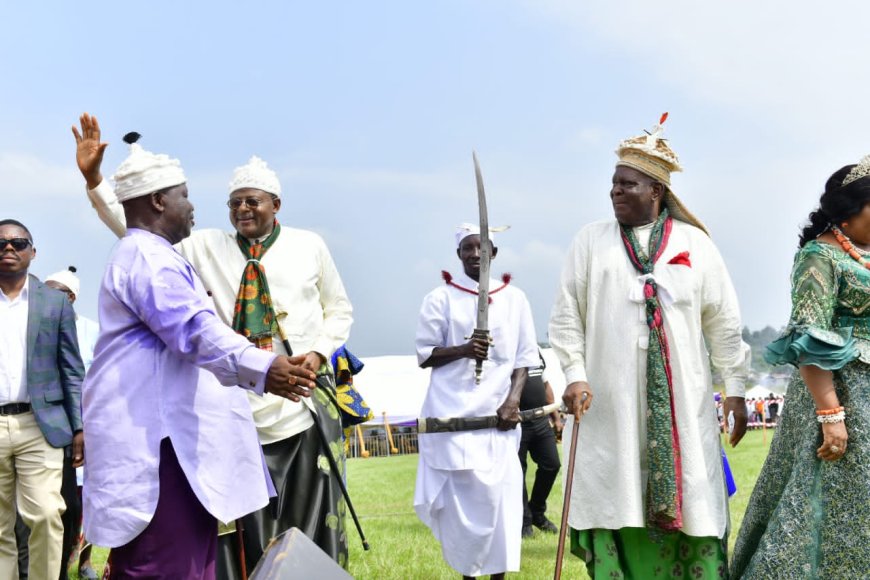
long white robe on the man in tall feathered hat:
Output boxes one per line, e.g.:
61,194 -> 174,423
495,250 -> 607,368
549,220 -> 749,538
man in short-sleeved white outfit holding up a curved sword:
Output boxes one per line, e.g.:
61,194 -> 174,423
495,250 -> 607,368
414,225 -> 540,578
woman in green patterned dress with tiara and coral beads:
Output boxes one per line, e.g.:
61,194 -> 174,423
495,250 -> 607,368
731,161 -> 870,579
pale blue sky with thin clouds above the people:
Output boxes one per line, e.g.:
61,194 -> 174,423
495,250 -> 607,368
0,0 -> 870,355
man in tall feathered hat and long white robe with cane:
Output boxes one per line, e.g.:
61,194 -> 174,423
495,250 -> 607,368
549,118 -> 749,578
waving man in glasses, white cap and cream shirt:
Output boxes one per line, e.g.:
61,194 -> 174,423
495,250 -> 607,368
77,114 -> 353,578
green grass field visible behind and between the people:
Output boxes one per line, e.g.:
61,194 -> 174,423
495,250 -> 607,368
72,431 -> 773,580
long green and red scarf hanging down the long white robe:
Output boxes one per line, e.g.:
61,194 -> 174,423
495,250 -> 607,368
620,209 -> 683,531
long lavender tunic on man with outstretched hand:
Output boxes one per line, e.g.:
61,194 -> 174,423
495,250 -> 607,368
82,228 -> 274,547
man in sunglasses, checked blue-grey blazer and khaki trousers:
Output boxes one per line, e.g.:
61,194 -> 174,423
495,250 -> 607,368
0,219 -> 84,579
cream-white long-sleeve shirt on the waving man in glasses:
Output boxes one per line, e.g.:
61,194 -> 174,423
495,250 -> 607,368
88,181 -> 353,444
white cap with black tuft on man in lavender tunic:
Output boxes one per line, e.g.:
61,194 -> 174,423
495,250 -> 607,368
112,133 -> 187,202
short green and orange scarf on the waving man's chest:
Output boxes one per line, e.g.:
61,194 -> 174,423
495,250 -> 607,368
233,220 -> 281,350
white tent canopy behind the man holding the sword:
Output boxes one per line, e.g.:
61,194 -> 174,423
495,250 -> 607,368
353,348 -> 565,424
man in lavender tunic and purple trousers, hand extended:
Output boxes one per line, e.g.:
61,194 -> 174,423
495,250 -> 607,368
71,129 -> 314,578
